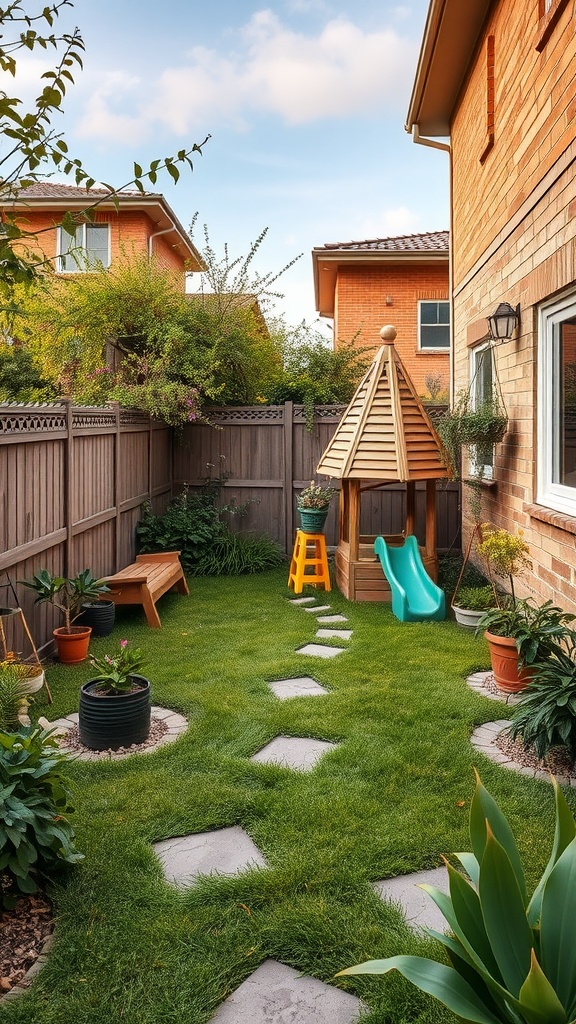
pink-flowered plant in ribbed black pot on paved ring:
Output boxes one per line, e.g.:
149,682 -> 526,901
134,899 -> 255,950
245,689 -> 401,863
78,640 -> 151,751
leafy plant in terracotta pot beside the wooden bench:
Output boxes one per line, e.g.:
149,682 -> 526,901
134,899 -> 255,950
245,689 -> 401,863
22,569 -> 110,665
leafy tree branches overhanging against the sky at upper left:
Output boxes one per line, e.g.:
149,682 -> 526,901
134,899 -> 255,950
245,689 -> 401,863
0,0 -> 207,310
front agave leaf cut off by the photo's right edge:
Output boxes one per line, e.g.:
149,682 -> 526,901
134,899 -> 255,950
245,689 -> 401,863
540,839 -> 576,1016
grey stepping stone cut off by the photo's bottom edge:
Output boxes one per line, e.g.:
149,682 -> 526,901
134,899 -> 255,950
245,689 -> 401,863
210,959 -> 365,1024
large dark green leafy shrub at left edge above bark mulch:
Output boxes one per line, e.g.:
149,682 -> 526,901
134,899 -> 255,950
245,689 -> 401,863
0,726 -> 83,905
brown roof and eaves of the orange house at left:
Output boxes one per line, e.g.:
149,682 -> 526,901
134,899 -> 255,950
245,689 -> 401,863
6,181 -> 206,270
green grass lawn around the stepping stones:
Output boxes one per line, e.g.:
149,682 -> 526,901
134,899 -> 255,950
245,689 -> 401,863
0,570 -> 574,1024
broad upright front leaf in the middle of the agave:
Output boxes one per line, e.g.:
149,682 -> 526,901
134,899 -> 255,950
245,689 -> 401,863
478,822 -> 534,996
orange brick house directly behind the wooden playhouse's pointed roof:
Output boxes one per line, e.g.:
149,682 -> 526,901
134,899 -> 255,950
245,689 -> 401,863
312,231 -> 450,395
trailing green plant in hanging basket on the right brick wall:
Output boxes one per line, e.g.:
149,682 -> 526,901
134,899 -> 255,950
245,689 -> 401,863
435,390 -> 508,479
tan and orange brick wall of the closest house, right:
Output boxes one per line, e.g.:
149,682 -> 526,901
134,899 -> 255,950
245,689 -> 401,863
452,0 -> 576,612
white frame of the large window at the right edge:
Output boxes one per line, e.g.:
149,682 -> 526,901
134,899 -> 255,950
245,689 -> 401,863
536,288 -> 576,516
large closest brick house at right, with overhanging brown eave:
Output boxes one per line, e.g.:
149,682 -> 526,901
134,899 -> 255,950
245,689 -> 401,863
406,0 -> 576,611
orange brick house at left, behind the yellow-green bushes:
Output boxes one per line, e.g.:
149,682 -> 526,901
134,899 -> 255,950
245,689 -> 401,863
6,181 -> 204,291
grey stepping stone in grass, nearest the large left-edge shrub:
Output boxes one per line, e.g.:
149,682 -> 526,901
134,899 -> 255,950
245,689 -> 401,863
154,825 -> 266,886
